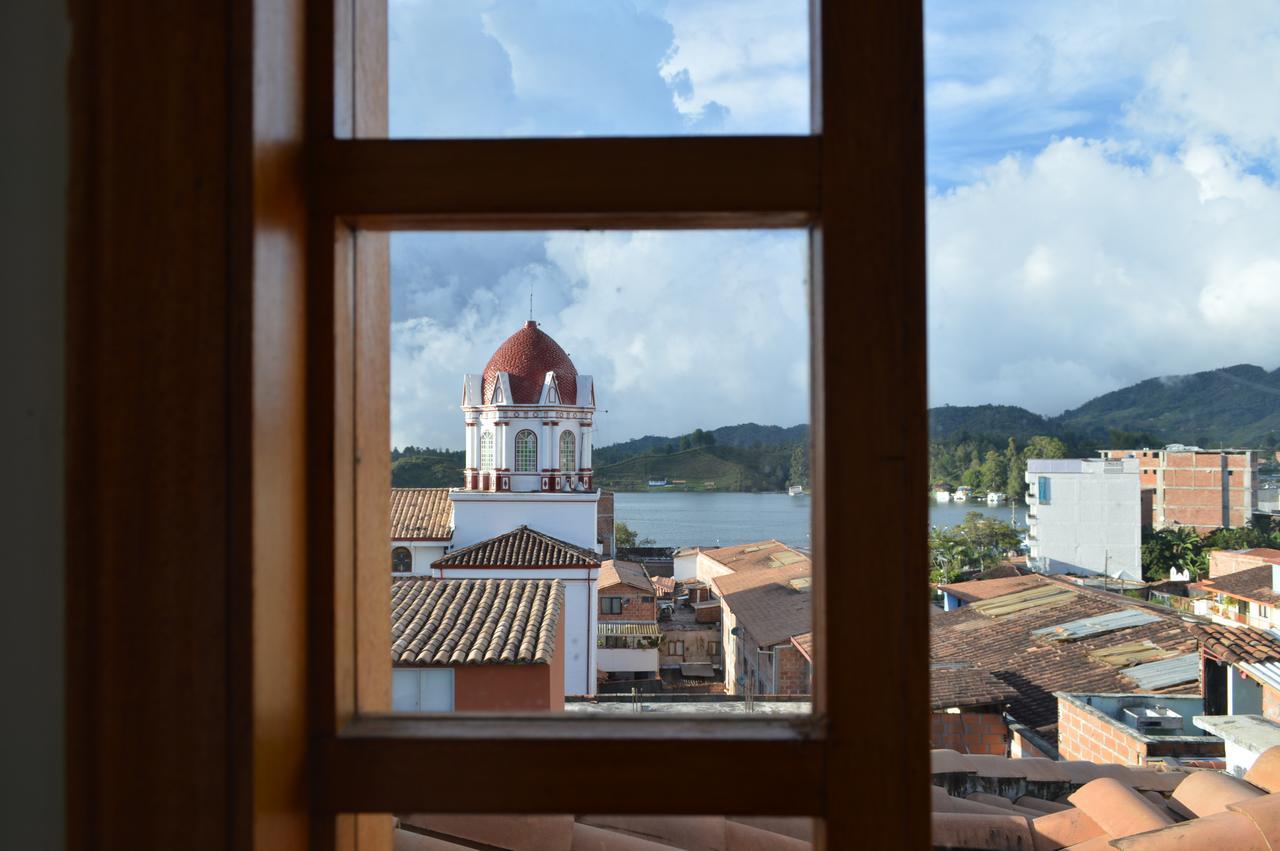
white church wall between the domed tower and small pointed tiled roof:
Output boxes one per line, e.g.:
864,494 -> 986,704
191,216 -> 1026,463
449,490 -> 600,553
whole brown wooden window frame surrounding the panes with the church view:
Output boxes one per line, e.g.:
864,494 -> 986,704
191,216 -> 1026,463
307,0 -> 929,848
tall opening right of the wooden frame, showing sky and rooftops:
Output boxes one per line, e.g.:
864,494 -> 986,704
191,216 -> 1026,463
920,1 -> 1280,847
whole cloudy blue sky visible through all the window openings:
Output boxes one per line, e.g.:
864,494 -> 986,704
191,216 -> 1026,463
390,0 -> 1280,447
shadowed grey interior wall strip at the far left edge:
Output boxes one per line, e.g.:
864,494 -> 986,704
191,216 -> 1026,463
0,0 -> 72,848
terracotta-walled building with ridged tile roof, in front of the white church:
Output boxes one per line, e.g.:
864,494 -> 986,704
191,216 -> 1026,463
392,576 -> 564,712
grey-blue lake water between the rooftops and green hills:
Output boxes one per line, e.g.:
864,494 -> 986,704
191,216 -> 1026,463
613,491 -> 1027,546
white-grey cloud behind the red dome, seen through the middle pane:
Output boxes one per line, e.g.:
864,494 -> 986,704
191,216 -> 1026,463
392,232 -> 809,447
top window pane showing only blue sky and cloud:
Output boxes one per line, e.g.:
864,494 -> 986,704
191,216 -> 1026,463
388,0 -> 809,138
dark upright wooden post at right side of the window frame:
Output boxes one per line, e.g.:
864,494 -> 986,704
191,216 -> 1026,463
813,0 -> 929,848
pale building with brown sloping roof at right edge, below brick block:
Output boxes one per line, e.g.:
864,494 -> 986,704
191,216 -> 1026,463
1193,548 -> 1280,630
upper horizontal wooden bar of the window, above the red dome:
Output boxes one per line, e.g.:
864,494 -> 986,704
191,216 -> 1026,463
312,136 -> 820,228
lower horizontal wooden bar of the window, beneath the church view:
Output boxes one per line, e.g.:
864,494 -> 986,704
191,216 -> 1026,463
317,715 -> 824,822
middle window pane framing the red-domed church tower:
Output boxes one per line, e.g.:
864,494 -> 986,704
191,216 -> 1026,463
389,230 -> 813,718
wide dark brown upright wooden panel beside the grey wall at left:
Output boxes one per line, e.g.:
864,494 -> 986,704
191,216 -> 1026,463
67,0 -> 234,850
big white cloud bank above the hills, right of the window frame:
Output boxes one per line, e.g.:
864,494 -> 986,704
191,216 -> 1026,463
929,139 -> 1280,413
